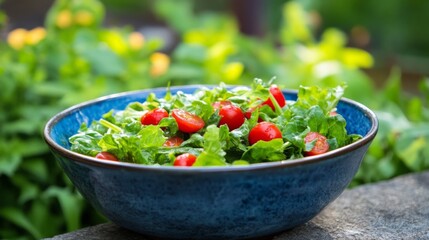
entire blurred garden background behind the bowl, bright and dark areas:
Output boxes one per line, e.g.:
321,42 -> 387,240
0,0 -> 429,239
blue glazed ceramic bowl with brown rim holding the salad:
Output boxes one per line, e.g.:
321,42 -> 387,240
44,86 -> 378,239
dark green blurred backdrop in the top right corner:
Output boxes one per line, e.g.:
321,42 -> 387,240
312,0 -> 429,57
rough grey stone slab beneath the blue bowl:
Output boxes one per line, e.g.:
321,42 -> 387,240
44,172 -> 429,240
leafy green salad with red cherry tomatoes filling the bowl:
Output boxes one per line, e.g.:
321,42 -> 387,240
69,79 -> 361,167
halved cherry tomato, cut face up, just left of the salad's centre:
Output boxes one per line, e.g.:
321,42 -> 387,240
171,109 -> 205,133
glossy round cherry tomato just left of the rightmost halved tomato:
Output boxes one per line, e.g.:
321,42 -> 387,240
249,122 -> 282,145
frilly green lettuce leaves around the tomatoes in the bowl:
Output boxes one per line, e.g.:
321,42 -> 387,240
69,79 -> 360,166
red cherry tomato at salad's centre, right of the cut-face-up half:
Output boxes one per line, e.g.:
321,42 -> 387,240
213,101 -> 245,131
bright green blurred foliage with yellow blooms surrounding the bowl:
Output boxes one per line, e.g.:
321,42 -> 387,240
0,0 -> 429,239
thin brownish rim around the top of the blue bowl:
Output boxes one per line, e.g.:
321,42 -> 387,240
43,84 -> 378,174
